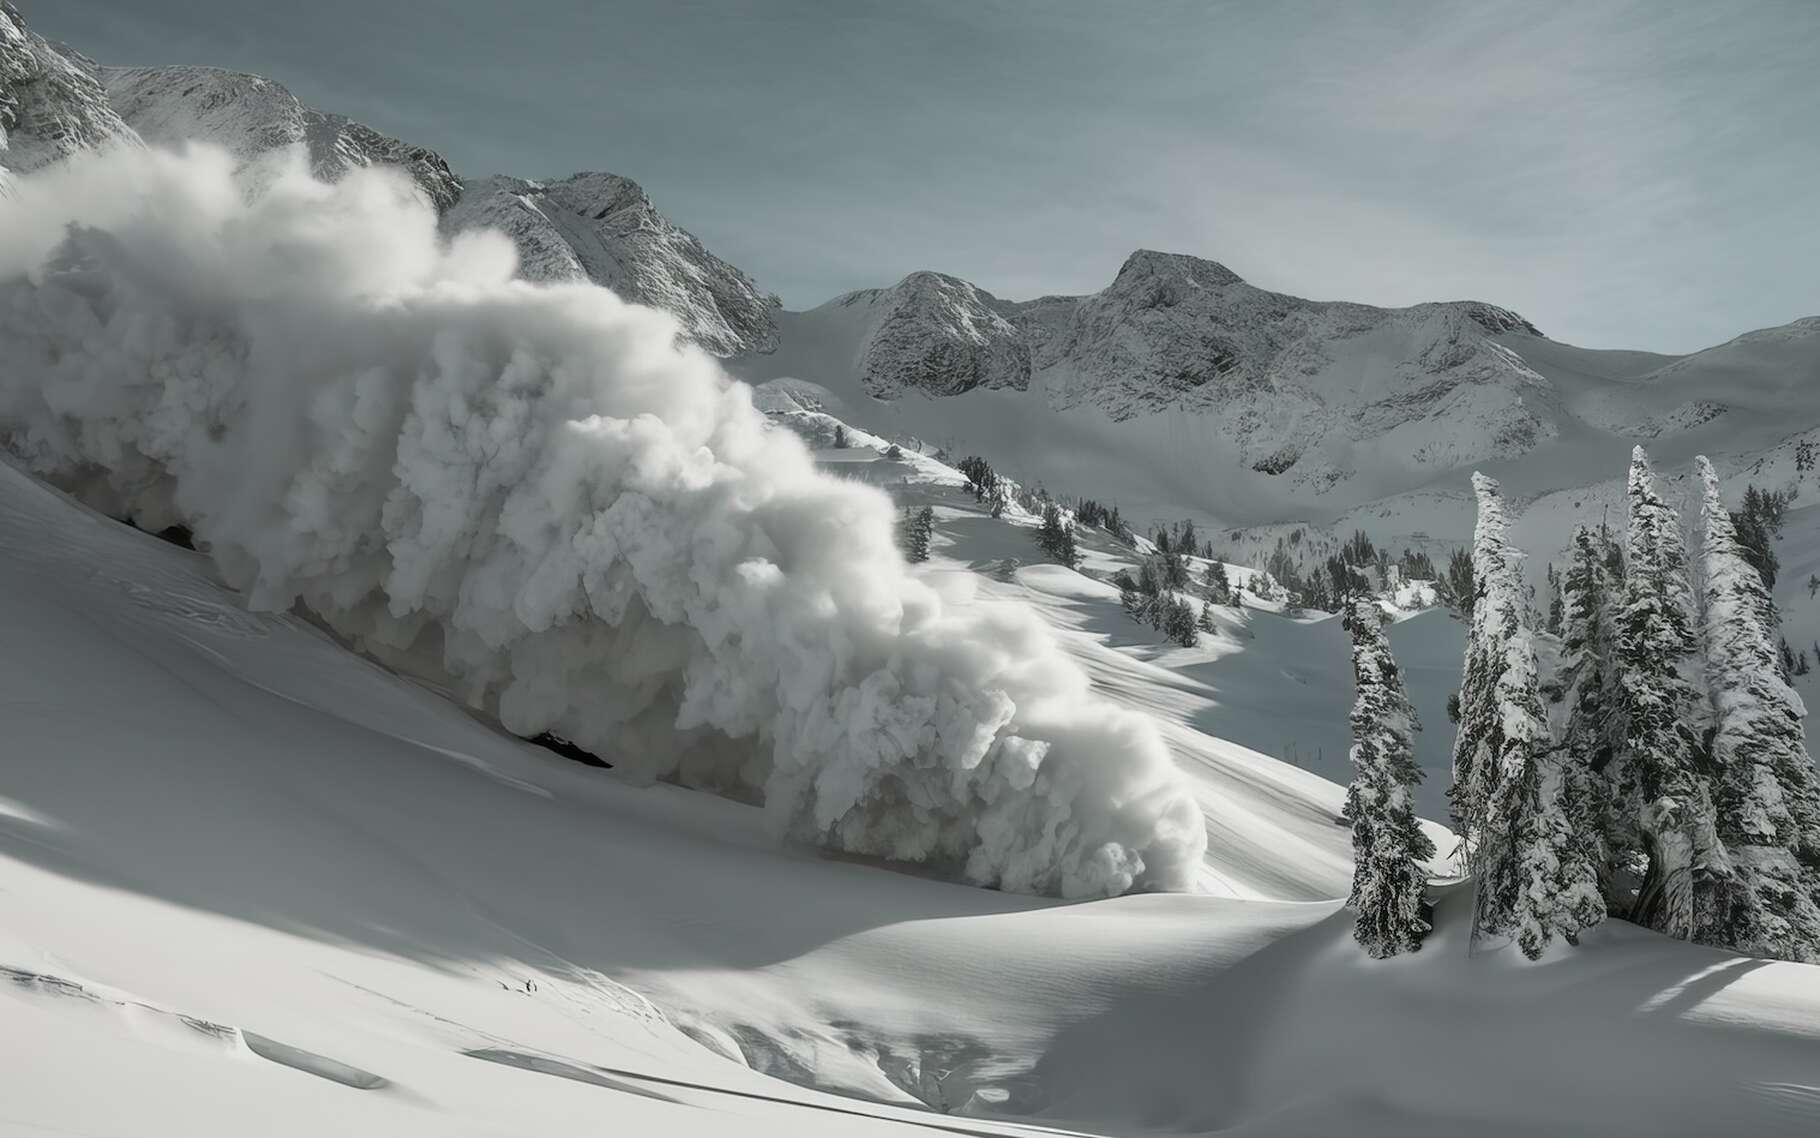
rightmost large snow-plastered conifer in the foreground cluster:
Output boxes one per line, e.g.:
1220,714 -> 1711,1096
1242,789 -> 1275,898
1696,457 -> 1820,963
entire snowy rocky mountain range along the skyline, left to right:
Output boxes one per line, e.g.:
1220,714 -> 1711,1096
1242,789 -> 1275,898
0,2 -> 1820,539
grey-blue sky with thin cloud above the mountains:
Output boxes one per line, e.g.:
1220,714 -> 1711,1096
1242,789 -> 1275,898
35,0 -> 1820,351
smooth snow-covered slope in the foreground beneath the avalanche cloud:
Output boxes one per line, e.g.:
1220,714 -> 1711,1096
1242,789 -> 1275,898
10,427 -> 1820,1138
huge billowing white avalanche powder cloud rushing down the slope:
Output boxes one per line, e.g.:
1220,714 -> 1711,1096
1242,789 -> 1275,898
0,149 -> 1205,896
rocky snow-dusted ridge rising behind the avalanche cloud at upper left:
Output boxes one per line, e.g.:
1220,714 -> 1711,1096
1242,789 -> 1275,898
0,4 -> 779,355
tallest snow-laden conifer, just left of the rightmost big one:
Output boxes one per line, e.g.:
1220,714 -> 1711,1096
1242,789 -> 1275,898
1611,446 -> 1736,940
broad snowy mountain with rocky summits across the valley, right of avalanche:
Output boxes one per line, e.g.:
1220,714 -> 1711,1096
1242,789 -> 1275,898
732,251 -> 1820,537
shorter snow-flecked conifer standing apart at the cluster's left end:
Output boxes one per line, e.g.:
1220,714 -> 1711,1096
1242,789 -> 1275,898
1345,597 -> 1434,958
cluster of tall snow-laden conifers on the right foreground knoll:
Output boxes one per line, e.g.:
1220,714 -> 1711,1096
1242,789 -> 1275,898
1347,448 -> 1820,961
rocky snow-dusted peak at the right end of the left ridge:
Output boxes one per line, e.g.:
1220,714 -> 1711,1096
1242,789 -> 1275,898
444,173 -> 779,355
